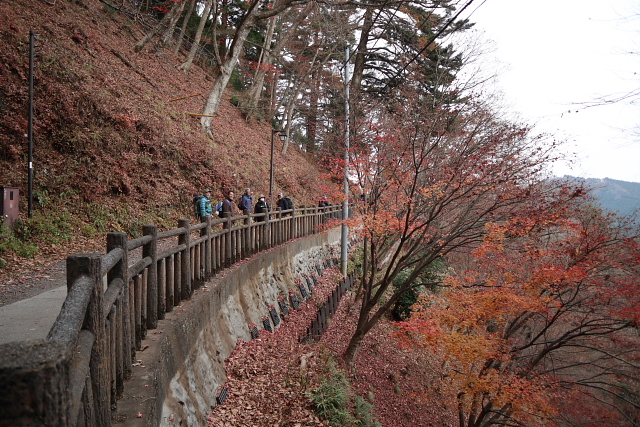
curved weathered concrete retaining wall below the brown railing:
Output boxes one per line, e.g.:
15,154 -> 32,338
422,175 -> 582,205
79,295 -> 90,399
115,228 -> 340,427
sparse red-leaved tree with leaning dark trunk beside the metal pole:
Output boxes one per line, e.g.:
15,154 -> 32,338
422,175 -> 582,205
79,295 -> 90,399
335,91 -> 577,363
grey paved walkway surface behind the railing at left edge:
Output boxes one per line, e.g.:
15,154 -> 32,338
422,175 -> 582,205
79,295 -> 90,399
0,285 -> 67,344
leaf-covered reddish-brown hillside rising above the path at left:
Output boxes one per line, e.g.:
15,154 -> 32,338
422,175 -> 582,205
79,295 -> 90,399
0,0 -> 330,279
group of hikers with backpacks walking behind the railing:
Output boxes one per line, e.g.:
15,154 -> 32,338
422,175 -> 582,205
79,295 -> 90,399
194,188 -> 331,221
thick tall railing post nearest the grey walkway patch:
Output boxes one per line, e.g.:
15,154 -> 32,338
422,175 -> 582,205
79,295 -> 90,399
67,254 -> 111,426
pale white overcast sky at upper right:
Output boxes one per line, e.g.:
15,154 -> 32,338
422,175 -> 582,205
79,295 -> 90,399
460,0 -> 640,182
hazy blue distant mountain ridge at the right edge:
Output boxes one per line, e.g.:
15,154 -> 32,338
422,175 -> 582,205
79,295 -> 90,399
564,175 -> 640,215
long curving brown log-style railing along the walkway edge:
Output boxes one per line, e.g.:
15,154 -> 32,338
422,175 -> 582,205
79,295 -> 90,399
0,206 -> 342,427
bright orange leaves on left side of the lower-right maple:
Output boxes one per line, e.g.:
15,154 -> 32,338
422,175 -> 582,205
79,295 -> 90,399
396,281 -> 564,425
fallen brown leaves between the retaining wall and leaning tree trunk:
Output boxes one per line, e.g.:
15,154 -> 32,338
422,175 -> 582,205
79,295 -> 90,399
208,268 -> 340,426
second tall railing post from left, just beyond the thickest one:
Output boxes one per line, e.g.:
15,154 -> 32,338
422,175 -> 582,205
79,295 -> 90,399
107,233 -> 135,379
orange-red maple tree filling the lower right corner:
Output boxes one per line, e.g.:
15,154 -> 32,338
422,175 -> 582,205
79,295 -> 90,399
397,192 -> 640,427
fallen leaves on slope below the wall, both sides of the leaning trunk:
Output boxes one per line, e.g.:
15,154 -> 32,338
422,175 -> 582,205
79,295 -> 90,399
208,268 -> 455,427
